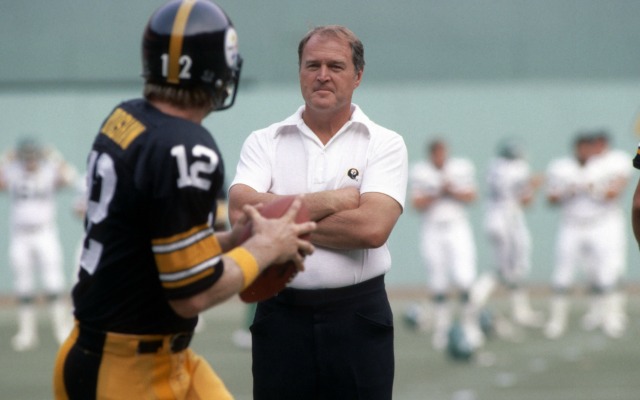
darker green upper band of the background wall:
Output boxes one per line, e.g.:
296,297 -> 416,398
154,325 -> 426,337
0,0 -> 640,85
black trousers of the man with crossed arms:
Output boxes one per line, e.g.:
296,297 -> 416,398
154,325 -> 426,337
251,277 -> 394,400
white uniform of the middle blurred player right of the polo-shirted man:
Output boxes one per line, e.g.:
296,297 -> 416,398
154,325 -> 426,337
485,158 -> 531,285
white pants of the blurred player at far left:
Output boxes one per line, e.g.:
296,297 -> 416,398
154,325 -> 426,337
9,227 -> 65,297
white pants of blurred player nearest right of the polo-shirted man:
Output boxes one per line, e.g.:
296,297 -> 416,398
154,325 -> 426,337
421,219 -> 477,293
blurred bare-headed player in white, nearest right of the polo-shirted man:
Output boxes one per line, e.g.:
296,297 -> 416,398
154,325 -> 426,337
409,139 -> 483,349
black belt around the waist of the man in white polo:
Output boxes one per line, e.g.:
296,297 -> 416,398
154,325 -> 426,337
273,275 -> 384,306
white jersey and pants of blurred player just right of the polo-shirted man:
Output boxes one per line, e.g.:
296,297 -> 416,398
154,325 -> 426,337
410,158 -> 476,294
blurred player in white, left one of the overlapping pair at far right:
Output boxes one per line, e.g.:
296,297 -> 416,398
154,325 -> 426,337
545,132 -> 620,339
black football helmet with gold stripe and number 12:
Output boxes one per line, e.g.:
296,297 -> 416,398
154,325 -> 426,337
142,0 -> 242,110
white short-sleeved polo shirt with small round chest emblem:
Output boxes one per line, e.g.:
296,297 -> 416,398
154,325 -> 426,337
231,104 -> 408,289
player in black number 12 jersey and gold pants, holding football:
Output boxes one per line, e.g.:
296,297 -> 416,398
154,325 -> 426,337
54,0 -> 314,400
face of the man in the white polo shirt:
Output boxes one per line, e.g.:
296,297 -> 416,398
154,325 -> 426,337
300,35 -> 362,112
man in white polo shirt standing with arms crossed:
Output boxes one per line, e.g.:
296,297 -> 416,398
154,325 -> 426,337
229,25 -> 408,400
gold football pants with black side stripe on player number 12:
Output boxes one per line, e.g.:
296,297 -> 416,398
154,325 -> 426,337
53,326 -> 233,400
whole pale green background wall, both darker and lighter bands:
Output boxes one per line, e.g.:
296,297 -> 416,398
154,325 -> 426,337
0,0 -> 640,293
